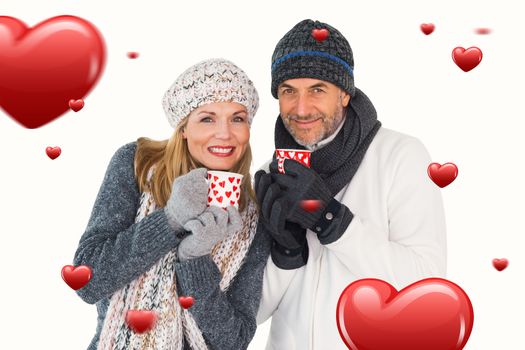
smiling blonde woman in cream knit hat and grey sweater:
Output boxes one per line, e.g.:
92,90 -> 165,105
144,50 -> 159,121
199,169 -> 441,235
74,59 -> 270,350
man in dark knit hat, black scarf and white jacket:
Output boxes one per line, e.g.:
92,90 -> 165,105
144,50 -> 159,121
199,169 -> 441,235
255,20 -> 446,350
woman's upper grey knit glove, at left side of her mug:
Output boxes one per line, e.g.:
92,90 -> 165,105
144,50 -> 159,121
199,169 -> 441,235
164,168 -> 208,231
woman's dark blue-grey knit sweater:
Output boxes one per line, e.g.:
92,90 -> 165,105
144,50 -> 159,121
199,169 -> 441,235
74,142 -> 271,350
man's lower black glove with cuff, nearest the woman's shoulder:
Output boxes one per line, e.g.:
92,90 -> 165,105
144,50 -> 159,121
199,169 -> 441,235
255,170 -> 308,270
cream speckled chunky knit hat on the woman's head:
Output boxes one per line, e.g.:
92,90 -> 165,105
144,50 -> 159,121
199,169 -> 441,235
162,58 -> 259,128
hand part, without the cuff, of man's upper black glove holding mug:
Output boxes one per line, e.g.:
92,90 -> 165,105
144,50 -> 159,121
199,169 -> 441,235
270,159 -> 333,229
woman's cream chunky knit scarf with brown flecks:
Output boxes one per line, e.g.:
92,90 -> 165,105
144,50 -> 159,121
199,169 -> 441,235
97,174 -> 258,350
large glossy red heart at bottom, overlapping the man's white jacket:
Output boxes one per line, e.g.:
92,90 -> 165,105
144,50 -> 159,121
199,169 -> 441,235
336,278 -> 474,350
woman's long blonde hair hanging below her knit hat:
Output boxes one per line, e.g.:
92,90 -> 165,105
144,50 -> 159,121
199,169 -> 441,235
135,117 -> 257,211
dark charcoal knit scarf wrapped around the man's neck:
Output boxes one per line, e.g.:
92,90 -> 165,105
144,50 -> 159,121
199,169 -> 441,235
274,89 -> 381,196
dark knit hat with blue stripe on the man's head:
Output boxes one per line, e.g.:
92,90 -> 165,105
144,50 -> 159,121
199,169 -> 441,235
272,19 -> 355,98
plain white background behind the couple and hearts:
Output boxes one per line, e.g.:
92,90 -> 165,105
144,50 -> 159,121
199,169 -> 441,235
0,0 -> 525,350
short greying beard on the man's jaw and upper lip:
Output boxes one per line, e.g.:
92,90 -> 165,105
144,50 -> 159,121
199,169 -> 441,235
283,106 -> 344,147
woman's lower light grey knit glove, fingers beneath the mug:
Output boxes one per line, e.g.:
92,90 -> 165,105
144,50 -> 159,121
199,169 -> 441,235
178,206 -> 242,261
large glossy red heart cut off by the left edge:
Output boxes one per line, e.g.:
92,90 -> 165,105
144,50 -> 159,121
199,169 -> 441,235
0,16 -> 106,129
